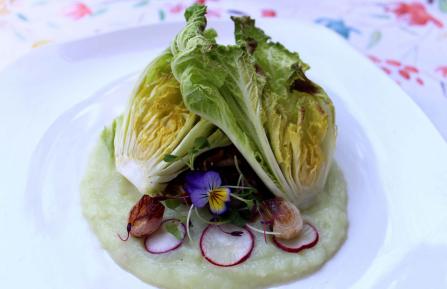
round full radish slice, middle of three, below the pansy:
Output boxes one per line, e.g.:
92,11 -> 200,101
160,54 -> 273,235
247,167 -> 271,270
200,224 -> 255,267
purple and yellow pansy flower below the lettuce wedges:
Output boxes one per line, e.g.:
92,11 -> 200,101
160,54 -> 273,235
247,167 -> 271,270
185,171 -> 230,215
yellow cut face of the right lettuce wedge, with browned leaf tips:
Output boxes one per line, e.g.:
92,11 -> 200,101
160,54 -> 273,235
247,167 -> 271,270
233,17 -> 336,206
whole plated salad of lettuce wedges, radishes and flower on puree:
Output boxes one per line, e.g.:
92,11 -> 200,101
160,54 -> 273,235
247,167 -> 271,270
81,5 -> 348,288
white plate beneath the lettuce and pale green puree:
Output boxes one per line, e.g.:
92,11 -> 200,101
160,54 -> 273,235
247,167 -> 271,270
0,21 -> 447,289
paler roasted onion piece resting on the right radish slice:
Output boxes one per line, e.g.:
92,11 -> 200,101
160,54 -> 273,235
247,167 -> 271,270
261,198 -> 303,240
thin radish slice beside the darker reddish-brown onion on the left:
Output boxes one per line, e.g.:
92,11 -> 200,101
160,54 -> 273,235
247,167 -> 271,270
144,219 -> 186,254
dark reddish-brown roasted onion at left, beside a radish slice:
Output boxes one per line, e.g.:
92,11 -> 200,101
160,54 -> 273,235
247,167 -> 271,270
128,195 -> 165,238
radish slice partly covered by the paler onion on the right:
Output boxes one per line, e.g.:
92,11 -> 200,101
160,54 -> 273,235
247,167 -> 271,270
273,223 -> 319,253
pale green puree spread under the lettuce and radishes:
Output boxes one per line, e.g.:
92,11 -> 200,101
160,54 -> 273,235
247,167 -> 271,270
81,128 -> 348,289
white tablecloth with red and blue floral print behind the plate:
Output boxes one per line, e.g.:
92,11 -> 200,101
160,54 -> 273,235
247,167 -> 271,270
0,0 -> 447,139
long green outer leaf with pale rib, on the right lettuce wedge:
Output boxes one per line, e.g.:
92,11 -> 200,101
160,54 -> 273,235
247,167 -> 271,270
171,5 -> 285,199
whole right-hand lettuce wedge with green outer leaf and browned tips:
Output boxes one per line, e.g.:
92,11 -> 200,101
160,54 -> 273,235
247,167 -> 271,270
171,5 -> 335,205
